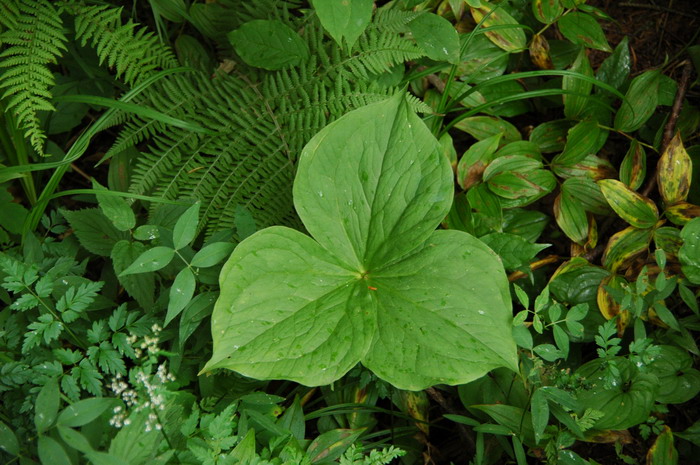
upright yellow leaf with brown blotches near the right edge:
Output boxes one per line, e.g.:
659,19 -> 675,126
657,132 -> 693,205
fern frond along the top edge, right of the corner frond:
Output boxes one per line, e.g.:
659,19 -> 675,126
66,2 -> 177,84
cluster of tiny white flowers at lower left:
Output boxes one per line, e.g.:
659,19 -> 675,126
109,324 -> 175,432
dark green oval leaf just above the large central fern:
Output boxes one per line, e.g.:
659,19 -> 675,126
228,19 -> 309,71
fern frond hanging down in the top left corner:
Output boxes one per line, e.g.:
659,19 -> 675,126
0,0 -> 66,153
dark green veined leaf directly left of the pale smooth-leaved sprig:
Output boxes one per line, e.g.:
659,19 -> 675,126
61,208 -> 129,257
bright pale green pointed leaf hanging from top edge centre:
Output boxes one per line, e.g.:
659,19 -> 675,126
312,0 -> 373,49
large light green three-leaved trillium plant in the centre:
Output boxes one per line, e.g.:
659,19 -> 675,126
203,95 -> 517,390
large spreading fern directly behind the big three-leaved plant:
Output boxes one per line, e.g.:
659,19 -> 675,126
122,8 -> 422,234
